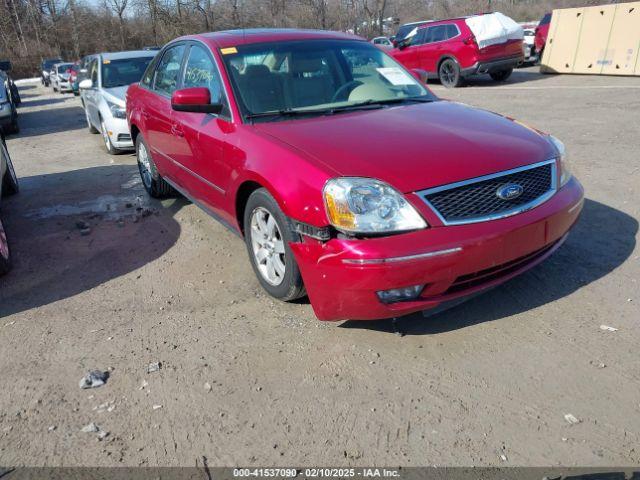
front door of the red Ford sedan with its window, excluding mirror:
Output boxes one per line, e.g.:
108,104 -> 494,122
172,42 -> 232,216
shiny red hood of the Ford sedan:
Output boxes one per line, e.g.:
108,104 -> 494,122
255,101 -> 555,193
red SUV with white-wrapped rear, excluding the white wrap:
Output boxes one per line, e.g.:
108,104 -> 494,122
389,14 -> 524,88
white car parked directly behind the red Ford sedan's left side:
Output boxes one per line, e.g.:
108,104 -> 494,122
80,50 -> 157,155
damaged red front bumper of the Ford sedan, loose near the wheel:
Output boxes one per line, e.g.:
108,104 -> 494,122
291,178 -> 583,320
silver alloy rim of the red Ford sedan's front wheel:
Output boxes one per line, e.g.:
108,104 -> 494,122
251,207 -> 286,286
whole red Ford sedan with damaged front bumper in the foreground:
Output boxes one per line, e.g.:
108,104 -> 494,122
127,30 -> 583,320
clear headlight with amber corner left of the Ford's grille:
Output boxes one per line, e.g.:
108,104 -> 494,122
323,177 -> 427,233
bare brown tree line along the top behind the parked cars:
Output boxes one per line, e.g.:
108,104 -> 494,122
0,0 -> 612,78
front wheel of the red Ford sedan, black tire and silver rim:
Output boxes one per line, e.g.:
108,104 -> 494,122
244,188 -> 306,302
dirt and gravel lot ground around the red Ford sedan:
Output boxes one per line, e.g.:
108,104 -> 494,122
0,68 -> 640,466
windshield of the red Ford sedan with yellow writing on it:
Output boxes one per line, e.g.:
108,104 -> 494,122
221,40 -> 435,121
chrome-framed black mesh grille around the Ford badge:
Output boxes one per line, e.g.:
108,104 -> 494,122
419,161 -> 555,225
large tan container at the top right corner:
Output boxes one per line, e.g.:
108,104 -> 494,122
540,2 -> 640,75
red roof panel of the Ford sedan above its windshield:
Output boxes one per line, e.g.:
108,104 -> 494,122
171,28 -> 366,48
